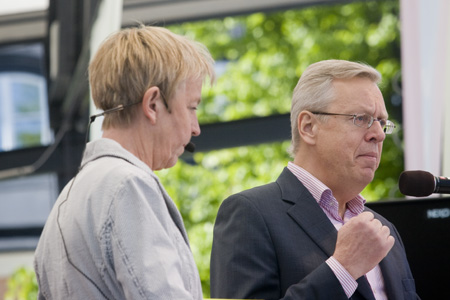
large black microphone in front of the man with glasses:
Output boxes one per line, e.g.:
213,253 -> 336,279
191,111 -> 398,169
398,170 -> 450,197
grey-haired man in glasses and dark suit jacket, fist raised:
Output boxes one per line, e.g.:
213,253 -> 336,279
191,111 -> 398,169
211,60 -> 418,300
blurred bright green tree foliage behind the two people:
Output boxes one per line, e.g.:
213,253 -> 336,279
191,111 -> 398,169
163,1 -> 403,297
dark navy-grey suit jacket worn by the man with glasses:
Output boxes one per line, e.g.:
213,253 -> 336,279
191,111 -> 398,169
211,168 -> 419,300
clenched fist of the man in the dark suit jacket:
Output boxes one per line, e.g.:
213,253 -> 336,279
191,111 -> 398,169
333,212 -> 395,280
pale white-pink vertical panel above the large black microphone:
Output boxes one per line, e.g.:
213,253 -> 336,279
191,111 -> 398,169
400,0 -> 450,176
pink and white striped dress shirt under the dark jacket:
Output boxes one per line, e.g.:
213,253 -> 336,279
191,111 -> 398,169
287,162 -> 388,300
